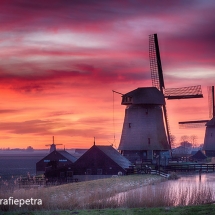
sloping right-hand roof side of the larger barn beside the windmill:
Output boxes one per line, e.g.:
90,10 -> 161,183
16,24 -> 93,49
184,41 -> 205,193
95,145 -> 132,169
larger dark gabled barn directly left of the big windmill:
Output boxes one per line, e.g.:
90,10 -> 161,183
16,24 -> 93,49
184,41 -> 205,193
74,144 -> 132,175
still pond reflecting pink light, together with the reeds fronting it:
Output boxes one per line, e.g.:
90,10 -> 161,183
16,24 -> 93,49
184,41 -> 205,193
115,173 -> 215,207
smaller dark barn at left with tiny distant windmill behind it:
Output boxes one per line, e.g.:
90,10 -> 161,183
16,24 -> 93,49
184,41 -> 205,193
36,150 -> 77,174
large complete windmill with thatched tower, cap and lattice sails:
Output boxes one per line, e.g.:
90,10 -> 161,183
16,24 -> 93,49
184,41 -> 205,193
118,34 -> 203,162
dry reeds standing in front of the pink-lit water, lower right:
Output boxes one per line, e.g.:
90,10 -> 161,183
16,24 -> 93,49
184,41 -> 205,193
116,182 -> 214,208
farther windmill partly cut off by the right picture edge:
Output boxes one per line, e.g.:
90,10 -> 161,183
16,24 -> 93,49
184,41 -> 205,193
179,86 -> 215,157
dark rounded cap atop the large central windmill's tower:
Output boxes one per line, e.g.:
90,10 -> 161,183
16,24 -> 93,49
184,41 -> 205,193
122,87 -> 165,105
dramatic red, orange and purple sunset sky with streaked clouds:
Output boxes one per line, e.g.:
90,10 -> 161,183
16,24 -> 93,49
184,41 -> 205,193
0,0 -> 215,149
